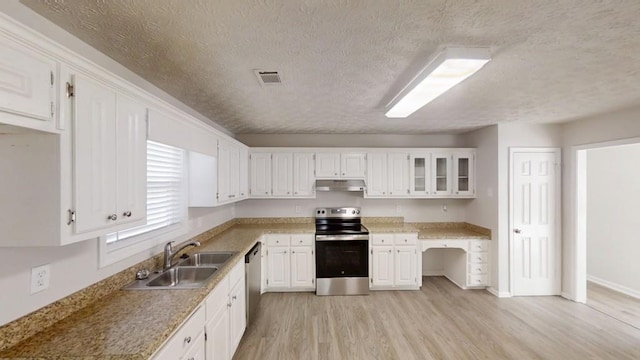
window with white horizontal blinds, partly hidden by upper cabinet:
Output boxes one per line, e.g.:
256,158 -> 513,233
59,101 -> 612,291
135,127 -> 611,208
100,141 -> 186,266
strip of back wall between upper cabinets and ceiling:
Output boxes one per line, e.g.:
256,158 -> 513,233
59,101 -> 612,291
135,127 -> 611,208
236,134 -> 463,147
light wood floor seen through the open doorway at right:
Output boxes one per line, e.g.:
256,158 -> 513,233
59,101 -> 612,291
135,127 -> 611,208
587,281 -> 640,329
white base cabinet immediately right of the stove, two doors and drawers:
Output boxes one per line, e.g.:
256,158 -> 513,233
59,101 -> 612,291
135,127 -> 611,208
369,233 -> 422,290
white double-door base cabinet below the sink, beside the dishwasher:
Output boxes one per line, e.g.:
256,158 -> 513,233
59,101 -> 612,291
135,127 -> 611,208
205,261 -> 247,360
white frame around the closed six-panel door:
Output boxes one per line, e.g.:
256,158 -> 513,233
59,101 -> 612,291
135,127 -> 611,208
508,147 -> 562,296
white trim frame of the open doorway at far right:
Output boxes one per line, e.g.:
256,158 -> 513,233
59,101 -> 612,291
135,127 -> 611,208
562,137 -> 640,303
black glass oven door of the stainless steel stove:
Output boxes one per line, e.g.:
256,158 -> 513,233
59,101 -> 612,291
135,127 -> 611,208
316,238 -> 369,279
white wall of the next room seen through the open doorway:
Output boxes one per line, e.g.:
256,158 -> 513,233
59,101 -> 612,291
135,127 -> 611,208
587,144 -> 640,294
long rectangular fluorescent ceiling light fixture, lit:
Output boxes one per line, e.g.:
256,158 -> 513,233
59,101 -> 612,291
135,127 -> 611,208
385,48 -> 491,118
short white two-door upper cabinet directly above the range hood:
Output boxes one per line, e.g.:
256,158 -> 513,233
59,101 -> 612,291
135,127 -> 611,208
316,152 -> 367,179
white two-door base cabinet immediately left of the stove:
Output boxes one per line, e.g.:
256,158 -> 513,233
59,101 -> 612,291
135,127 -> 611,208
265,234 -> 315,291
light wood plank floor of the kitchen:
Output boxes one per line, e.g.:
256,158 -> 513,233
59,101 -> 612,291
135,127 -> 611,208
234,277 -> 640,360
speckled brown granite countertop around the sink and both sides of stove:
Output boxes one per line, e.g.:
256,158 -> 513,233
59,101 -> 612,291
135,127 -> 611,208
0,220 -> 490,360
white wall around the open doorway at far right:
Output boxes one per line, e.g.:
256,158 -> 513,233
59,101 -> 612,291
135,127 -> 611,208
562,107 -> 640,300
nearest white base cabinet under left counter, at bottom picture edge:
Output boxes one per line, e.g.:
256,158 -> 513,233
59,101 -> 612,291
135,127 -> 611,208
153,306 -> 205,360
